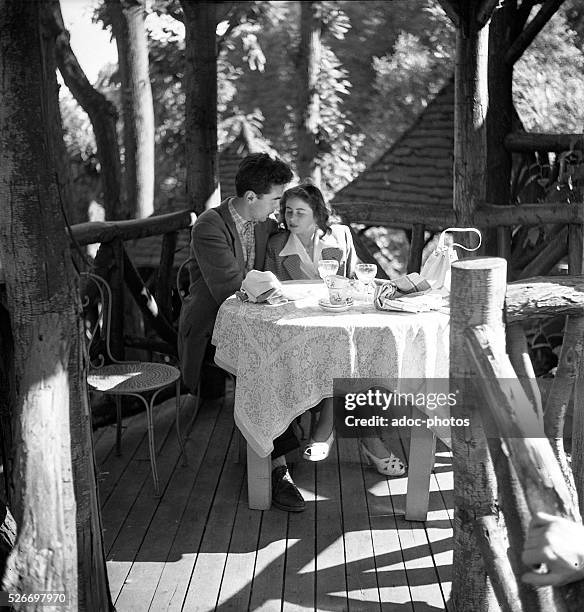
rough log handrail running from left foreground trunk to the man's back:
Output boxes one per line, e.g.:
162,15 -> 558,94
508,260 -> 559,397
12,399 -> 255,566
71,210 -> 197,245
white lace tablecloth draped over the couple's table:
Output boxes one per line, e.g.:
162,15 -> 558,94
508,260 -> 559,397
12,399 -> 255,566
212,282 -> 449,457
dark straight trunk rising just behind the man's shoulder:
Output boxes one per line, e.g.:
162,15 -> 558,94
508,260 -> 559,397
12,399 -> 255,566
181,0 -> 221,213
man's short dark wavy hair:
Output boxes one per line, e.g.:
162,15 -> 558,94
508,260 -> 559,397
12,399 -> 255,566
235,153 -> 292,198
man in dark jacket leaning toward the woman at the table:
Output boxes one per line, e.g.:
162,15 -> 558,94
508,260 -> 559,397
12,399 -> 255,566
178,153 -> 305,512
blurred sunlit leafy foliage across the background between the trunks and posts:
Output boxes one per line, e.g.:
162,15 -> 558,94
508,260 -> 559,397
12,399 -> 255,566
62,0 -> 584,222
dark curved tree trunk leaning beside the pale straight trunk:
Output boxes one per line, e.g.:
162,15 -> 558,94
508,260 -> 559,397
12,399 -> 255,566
51,2 -> 124,224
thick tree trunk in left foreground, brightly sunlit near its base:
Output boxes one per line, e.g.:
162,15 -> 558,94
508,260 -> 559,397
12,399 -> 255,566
0,0 -> 111,610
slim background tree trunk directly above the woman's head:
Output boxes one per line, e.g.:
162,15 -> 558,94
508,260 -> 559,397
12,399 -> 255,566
296,2 -> 322,186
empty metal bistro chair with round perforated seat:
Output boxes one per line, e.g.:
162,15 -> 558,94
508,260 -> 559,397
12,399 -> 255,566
81,272 -> 186,497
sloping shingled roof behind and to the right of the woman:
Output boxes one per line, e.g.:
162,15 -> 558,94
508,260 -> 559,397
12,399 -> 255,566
331,80 -> 454,212
